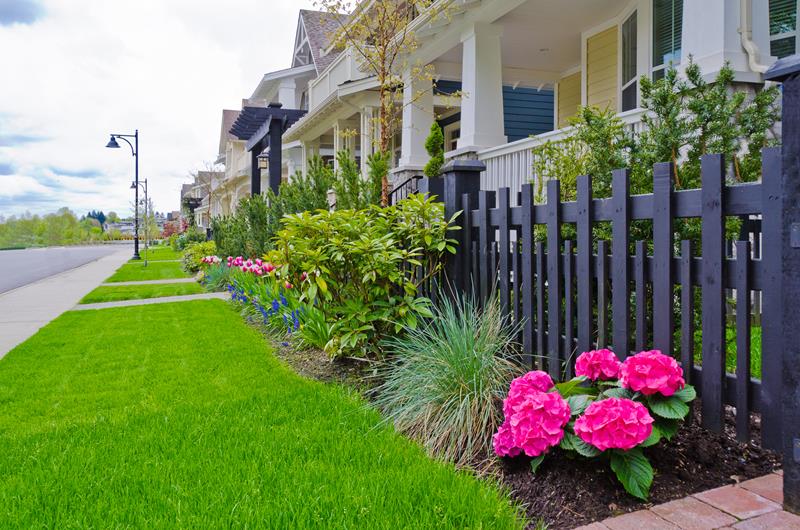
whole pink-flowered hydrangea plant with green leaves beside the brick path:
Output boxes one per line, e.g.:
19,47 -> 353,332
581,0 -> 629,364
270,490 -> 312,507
493,349 -> 696,500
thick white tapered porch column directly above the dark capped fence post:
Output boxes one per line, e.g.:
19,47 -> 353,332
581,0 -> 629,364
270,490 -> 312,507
458,23 -> 507,150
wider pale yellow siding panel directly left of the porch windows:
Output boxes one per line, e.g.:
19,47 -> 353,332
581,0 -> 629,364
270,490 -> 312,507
586,26 -> 618,112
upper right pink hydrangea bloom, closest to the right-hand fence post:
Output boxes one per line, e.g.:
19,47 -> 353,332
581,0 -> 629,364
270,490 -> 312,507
619,350 -> 686,396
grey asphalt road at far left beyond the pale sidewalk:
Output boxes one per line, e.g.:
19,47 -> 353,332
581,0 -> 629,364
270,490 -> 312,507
0,245 -> 133,293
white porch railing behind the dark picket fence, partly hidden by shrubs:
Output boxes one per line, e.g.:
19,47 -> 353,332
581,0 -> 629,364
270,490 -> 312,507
478,110 -> 645,205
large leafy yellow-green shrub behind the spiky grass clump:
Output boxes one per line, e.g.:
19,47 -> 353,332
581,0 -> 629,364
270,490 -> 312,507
266,195 -> 455,356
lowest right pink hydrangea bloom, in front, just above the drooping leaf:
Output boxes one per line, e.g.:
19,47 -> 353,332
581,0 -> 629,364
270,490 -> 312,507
575,398 -> 653,451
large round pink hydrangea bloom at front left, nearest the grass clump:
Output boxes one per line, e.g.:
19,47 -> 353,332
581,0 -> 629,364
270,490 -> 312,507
506,392 -> 570,456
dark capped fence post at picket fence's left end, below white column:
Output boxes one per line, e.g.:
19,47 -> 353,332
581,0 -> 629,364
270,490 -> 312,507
442,160 -> 486,291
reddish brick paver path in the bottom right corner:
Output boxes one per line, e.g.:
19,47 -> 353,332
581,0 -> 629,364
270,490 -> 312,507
577,471 -> 800,530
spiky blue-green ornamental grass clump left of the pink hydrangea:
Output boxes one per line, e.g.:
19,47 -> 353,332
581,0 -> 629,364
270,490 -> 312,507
374,295 -> 533,465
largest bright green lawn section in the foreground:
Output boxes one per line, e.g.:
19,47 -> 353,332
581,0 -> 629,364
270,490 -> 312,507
0,300 -> 522,529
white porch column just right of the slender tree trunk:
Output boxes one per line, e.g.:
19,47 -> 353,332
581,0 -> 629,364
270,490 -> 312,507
400,71 -> 433,169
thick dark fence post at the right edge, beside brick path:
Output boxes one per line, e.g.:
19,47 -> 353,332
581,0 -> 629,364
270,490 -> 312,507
764,55 -> 800,513
